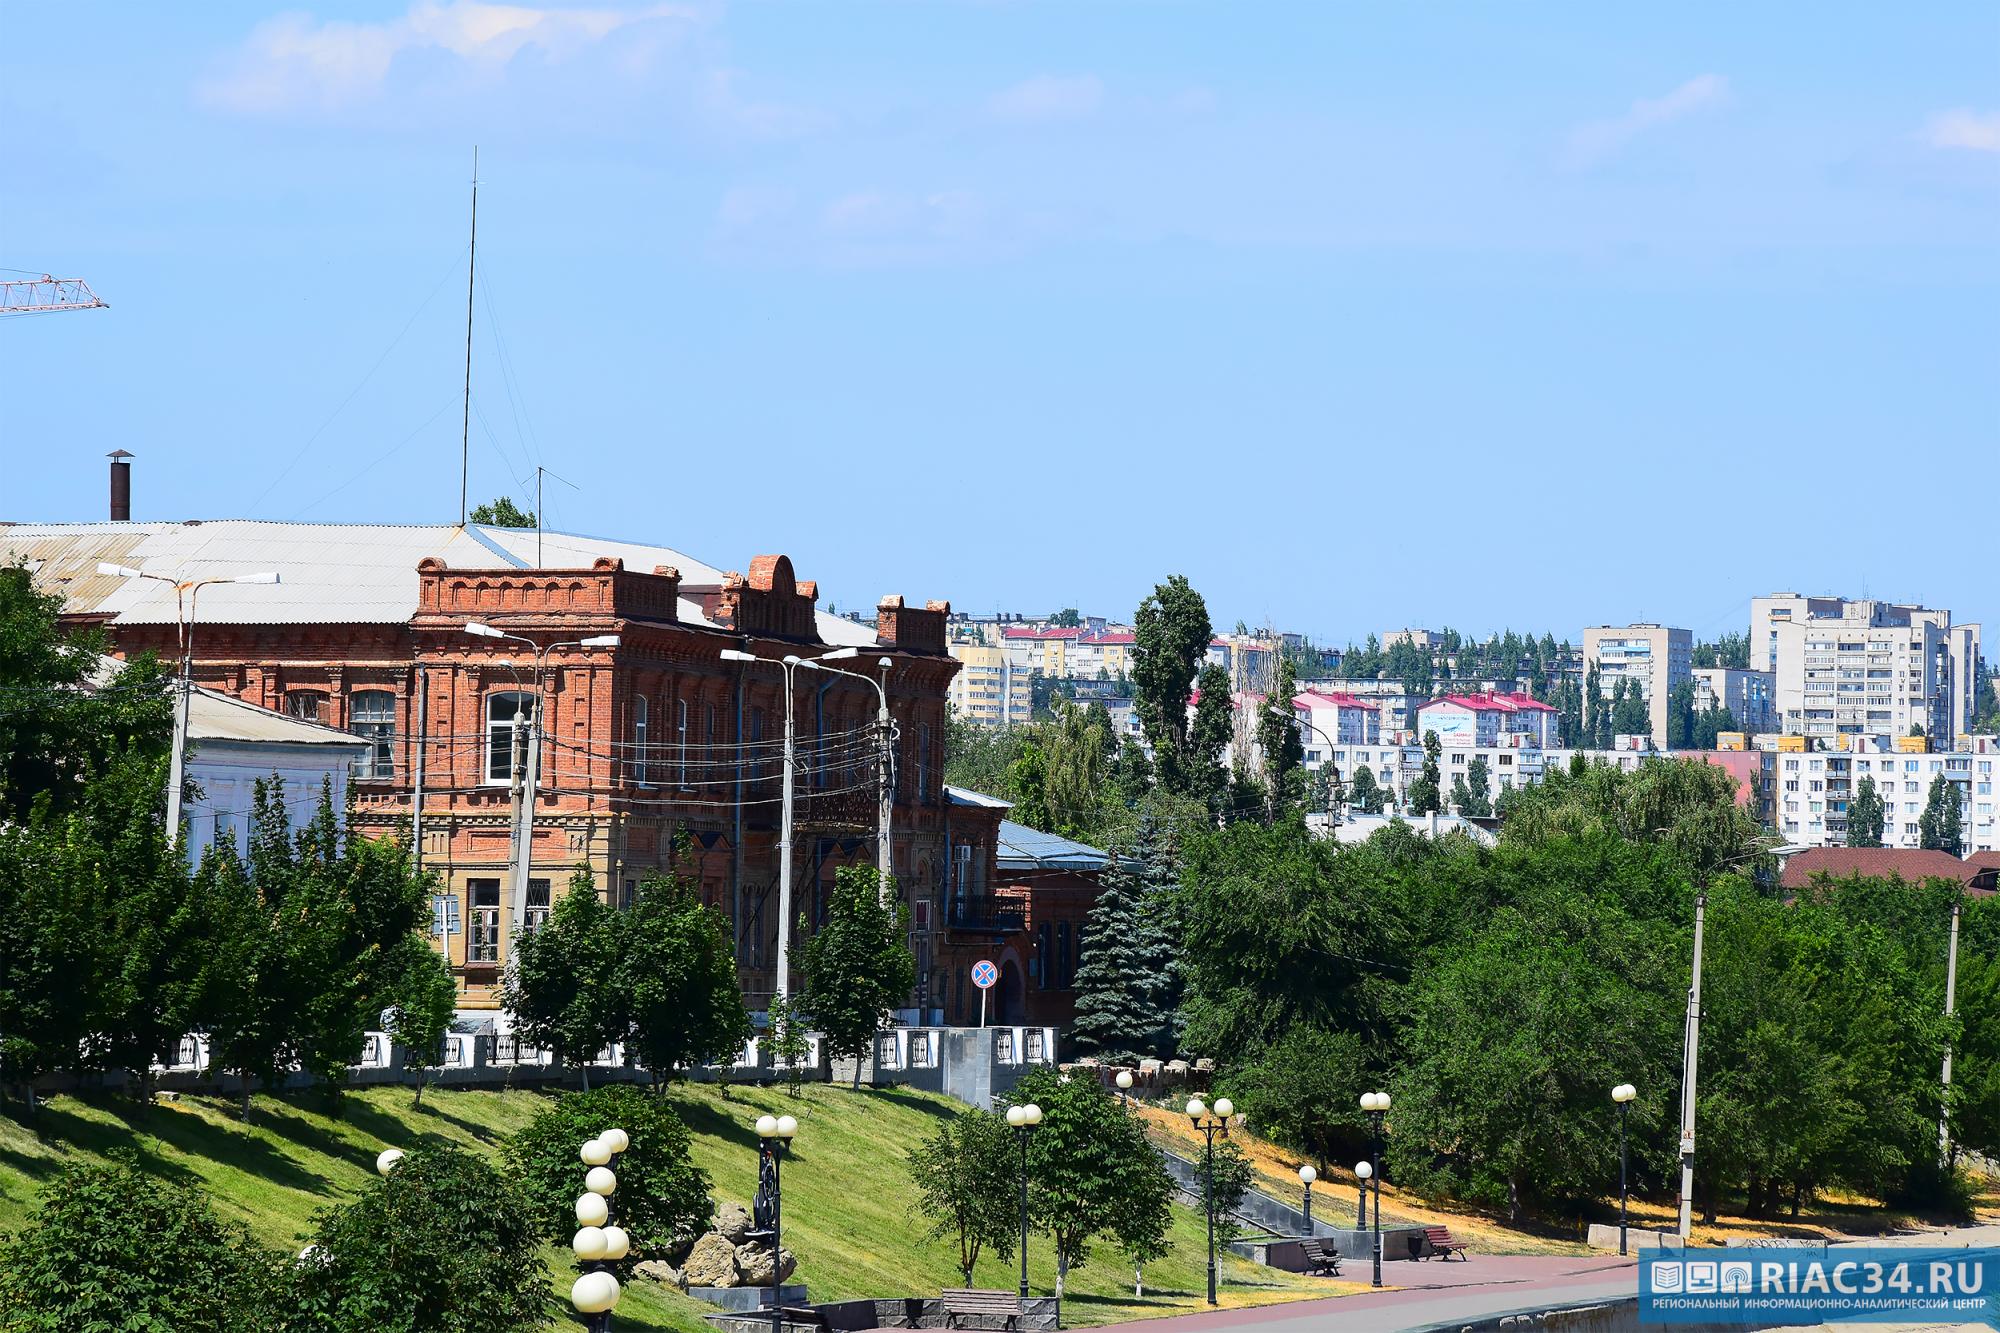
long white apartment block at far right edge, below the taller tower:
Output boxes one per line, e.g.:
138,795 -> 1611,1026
1770,737 -> 2000,853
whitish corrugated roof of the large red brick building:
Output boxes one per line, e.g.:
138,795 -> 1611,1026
0,518 -> 876,646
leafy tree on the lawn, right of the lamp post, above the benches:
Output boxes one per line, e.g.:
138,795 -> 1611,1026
1012,1067 -> 1174,1299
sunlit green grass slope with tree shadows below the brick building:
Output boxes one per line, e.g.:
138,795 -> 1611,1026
0,1085 -> 1352,1333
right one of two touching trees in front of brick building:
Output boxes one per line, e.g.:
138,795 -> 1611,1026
616,873 -> 752,1089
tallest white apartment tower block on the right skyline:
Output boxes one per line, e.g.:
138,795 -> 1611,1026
1750,592 -> 1980,741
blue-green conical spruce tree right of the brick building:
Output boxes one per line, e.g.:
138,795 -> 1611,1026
1070,813 -> 1174,1061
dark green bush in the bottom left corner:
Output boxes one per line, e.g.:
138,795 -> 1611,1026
0,1161 -> 278,1333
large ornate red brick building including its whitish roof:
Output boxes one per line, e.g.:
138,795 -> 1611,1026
11,520 -> 994,1009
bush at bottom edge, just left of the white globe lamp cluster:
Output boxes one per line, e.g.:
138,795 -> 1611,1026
280,1149 -> 554,1333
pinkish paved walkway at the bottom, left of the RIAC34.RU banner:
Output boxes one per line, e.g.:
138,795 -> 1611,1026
1096,1255 -> 1638,1333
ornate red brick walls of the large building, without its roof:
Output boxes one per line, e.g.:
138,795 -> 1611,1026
58,528 -> 964,1009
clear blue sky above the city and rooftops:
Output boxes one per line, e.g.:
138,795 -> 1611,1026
0,0 -> 2000,640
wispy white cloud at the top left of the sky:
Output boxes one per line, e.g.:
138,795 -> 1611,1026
202,0 -> 694,112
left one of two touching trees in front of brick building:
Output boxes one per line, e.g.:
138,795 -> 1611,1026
500,867 -> 630,1089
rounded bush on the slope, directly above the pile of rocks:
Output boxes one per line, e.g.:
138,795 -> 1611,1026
508,1083 -> 714,1269
